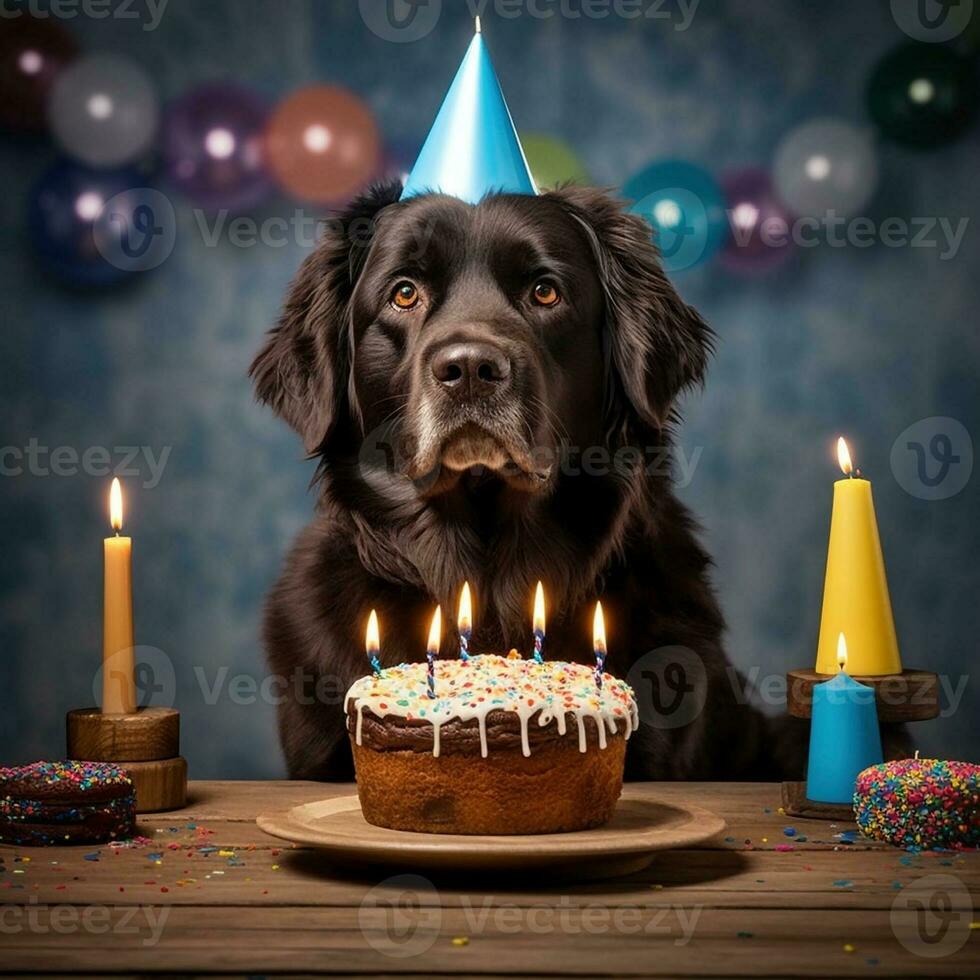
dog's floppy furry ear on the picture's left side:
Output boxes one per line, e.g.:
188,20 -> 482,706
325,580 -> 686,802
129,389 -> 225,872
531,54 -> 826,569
249,182 -> 401,455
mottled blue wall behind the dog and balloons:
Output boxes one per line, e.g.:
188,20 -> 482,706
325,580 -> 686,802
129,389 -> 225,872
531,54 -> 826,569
0,0 -> 980,777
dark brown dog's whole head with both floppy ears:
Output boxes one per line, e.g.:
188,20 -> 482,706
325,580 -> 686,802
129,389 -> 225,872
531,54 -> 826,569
252,188 -> 709,494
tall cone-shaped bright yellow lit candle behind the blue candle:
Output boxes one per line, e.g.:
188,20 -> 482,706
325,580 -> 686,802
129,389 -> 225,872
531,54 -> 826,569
816,438 -> 902,676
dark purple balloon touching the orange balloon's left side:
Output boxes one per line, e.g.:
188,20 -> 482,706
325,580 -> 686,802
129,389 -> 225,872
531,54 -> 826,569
163,83 -> 274,212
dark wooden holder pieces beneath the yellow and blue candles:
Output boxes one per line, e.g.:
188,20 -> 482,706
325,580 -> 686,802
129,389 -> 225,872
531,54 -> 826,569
782,670 -> 940,822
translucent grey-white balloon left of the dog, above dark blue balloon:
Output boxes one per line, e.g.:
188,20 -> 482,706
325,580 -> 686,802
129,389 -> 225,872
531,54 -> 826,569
48,55 -> 159,167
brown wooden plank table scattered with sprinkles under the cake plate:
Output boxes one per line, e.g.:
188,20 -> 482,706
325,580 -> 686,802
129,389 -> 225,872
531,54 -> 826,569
0,782 -> 980,977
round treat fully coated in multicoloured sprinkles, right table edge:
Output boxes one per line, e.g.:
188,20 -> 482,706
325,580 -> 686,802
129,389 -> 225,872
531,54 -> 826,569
854,759 -> 980,850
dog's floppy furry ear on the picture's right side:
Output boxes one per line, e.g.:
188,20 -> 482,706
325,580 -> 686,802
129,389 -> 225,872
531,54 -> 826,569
554,187 -> 714,429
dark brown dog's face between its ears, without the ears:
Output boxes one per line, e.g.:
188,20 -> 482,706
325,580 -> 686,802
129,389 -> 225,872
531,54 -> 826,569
351,196 -> 603,492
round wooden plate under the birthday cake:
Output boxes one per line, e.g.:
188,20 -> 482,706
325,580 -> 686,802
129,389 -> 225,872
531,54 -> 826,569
257,790 -> 725,879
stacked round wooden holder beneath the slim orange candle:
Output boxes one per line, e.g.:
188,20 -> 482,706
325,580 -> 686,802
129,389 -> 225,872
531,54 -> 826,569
66,708 -> 187,813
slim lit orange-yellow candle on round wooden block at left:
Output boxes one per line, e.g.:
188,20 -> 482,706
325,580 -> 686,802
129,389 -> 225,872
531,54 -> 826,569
102,479 -> 136,715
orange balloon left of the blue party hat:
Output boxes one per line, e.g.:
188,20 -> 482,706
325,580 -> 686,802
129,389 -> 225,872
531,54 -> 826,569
266,85 -> 381,204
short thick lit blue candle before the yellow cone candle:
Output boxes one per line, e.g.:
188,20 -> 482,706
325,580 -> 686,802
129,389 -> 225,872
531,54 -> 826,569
806,633 -> 882,803
